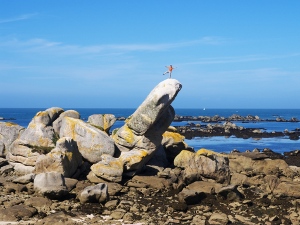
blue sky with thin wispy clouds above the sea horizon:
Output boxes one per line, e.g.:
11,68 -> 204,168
0,0 -> 300,109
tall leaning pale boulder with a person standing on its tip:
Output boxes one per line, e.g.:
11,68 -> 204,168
113,79 -> 182,171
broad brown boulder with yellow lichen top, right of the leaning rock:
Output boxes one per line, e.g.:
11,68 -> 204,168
174,150 -> 230,184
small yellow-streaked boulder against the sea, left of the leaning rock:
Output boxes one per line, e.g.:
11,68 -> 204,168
87,114 -> 117,133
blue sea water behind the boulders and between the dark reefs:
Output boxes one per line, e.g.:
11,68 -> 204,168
0,108 -> 300,154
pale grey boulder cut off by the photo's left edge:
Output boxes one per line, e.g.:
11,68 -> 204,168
0,122 -> 25,157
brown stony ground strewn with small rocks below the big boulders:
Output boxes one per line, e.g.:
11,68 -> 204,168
0,151 -> 300,225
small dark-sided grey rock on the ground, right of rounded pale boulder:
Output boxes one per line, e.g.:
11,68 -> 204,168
78,183 -> 109,203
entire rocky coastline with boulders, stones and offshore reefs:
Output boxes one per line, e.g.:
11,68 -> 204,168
0,79 -> 300,225
